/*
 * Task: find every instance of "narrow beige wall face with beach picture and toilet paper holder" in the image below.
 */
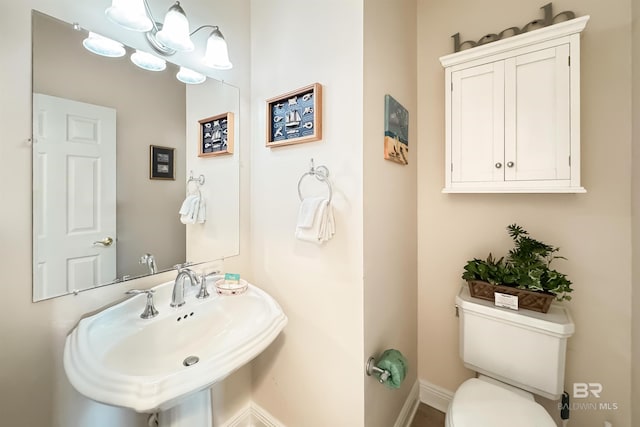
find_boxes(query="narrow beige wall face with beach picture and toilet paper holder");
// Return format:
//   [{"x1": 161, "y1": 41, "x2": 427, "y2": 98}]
[{"x1": 363, "y1": 0, "x2": 419, "y2": 427}]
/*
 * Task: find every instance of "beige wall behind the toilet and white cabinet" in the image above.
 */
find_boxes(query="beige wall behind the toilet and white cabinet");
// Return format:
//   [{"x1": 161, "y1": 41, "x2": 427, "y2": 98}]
[{"x1": 418, "y1": 0, "x2": 631, "y2": 426}]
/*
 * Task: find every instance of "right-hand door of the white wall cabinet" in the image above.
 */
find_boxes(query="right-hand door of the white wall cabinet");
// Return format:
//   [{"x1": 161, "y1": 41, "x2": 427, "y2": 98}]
[{"x1": 504, "y1": 44, "x2": 571, "y2": 181}]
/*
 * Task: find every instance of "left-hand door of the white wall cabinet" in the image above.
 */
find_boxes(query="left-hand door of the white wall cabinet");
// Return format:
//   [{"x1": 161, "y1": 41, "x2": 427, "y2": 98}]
[{"x1": 449, "y1": 61, "x2": 504, "y2": 182}]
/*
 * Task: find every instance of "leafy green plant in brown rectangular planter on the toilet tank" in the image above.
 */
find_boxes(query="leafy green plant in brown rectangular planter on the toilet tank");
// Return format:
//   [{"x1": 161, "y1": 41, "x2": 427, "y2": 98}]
[{"x1": 462, "y1": 224, "x2": 573, "y2": 313}]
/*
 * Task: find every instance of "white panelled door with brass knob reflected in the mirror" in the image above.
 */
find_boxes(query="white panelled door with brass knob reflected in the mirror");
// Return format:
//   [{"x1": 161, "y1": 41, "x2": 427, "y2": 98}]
[{"x1": 33, "y1": 94, "x2": 116, "y2": 299}]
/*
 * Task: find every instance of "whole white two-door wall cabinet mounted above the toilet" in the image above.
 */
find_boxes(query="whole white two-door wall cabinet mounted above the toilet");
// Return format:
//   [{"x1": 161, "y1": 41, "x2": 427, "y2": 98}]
[{"x1": 440, "y1": 16, "x2": 589, "y2": 193}]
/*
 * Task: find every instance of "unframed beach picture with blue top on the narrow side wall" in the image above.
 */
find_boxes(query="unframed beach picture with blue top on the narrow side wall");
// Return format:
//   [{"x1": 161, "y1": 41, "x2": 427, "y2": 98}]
[{"x1": 384, "y1": 95, "x2": 409, "y2": 165}]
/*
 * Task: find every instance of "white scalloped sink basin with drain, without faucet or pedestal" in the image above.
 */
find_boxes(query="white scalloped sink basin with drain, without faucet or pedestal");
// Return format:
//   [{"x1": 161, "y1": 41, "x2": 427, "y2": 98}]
[{"x1": 64, "y1": 281, "x2": 287, "y2": 412}]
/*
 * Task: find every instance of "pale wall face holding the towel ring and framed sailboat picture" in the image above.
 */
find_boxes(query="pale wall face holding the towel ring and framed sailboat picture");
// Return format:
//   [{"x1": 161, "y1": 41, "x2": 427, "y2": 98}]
[{"x1": 250, "y1": 0, "x2": 364, "y2": 427}]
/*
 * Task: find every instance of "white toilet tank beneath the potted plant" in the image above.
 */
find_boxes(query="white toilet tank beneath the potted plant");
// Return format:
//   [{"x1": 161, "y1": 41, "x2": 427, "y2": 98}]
[{"x1": 456, "y1": 284, "x2": 575, "y2": 400}]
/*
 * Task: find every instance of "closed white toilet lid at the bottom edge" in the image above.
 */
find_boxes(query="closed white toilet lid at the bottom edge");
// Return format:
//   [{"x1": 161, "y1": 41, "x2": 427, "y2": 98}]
[{"x1": 448, "y1": 378, "x2": 556, "y2": 427}]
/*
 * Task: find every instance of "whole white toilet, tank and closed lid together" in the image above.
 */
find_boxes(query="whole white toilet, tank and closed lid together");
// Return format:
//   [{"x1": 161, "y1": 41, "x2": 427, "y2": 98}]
[{"x1": 445, "y1": 285, "x2": 575, "y2": 427}]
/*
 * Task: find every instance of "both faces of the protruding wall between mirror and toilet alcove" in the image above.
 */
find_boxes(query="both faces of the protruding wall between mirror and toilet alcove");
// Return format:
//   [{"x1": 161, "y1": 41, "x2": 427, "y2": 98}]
[{"x1": 251, "y1": 0, "x2": 417, "y2": 426}]
